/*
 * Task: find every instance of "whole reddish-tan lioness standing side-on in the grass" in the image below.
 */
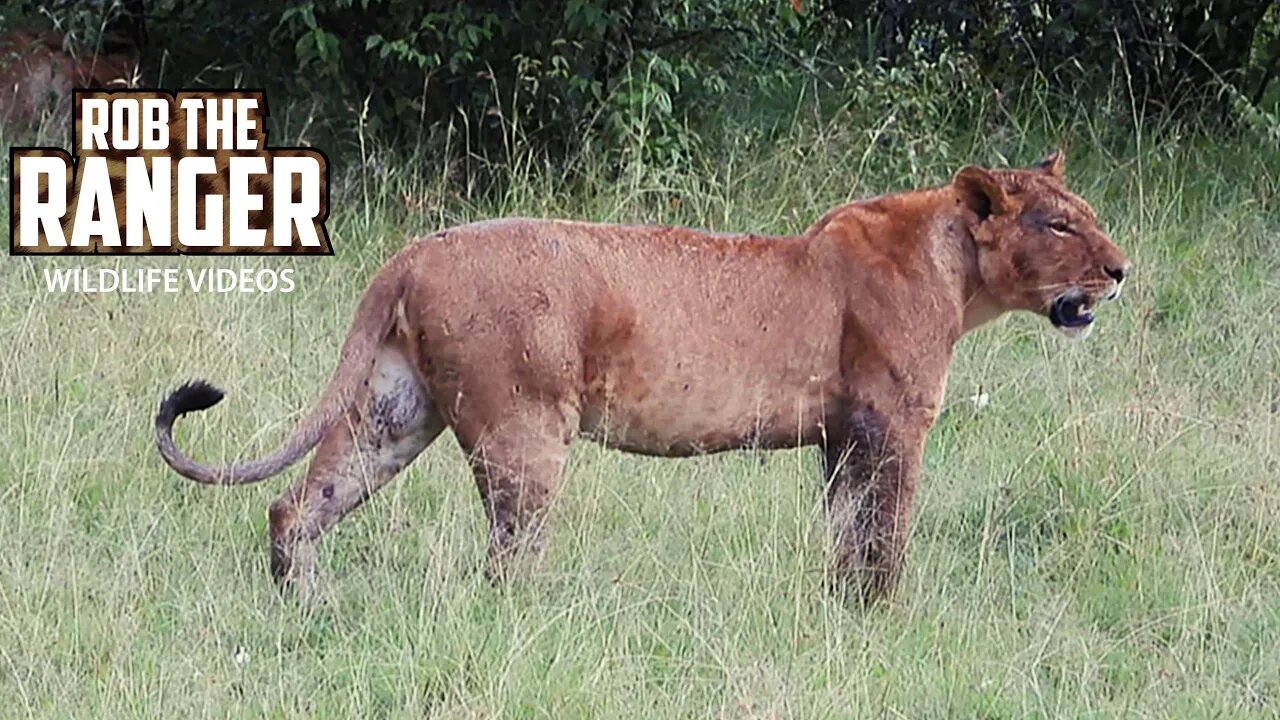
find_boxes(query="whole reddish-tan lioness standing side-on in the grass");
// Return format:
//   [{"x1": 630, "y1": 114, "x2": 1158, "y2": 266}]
[{"x1": 156, "y1": 152, "x2": 1129, "y2": 600}]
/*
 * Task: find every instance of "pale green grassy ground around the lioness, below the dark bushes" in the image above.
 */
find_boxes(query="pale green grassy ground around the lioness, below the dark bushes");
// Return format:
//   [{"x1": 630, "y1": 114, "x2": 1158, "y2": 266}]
[{"x1": 0, "y1": 90, "x2": 1280, "y2": 717}]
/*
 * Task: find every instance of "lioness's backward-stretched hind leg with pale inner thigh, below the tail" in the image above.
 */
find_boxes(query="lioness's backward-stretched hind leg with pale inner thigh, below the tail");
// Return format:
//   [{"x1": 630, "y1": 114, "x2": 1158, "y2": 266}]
[{"x1": 269, "y1": 346, "x2": 444, "y2": 585}]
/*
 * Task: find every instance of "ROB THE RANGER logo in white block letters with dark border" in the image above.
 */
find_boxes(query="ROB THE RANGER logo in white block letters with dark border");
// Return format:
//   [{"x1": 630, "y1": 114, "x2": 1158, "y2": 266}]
[{"x1": 9, "y1": 90, "x2": 333, "y2": 253}]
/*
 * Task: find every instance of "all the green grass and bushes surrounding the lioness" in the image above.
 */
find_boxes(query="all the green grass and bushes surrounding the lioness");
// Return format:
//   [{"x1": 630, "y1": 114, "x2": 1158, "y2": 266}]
[{"x1": 0, "y1": 1, "x2": 1280, "y2": 717}]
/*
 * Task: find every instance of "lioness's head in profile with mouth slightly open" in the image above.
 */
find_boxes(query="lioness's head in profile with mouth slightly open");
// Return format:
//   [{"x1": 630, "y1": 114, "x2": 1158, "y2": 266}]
[{"x1": 952, "y1": 152, "x2": 1130, "y2": 337}]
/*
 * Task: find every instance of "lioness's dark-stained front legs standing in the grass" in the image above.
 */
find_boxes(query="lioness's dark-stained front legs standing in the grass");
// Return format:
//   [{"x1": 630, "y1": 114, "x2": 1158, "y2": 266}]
[{"x1": 823, "y1": 410, "x2": 924, "y2": 602}]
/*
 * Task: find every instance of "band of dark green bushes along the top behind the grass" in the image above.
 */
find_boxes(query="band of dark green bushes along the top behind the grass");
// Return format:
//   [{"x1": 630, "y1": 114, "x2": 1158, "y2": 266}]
[{"x1": 14, "y1": 0, "x2": 1280, "y2": 168}]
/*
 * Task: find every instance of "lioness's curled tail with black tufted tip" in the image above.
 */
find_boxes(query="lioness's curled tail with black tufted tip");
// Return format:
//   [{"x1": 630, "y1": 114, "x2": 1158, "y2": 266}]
[{"x1": 156, "y1": 254, "x2": 404, "y2": 486}]
